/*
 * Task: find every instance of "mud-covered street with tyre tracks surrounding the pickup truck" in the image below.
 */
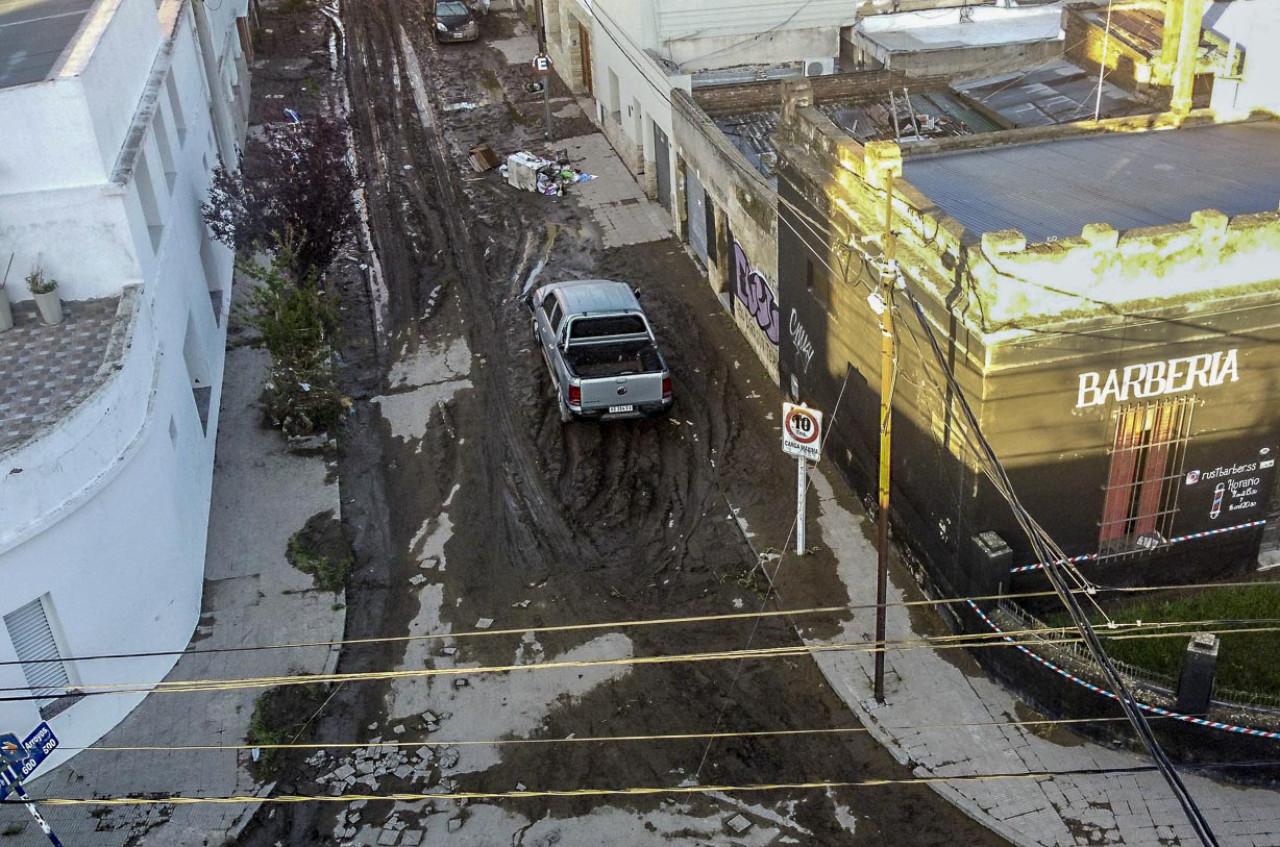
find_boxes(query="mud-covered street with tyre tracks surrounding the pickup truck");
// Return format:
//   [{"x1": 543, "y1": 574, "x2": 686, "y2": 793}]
[{"x1": 232, "y1": 0, "x2": 1002, "y2": 847}]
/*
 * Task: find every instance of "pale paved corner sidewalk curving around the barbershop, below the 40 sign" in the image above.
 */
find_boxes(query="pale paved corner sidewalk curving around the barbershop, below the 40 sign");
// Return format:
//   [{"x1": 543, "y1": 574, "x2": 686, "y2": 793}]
[{"x1": 809, "y1": 471, "x2": 1280, "y2": 847}]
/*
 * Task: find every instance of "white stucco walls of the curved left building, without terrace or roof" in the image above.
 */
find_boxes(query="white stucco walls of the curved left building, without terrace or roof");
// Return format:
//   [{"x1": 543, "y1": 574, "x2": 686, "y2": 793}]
[{"x1": 0, "y1": 0, "x2": 240, "y2": 772}]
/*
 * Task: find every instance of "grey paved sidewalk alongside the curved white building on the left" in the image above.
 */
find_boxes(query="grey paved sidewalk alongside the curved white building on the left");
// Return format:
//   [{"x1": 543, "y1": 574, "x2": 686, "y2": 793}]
[{"x1": 0, "y1": 289, "x2": 346, "y2": 847}]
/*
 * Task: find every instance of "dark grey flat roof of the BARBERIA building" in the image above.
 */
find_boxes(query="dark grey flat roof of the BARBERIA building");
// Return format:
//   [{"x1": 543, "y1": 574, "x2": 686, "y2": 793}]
[{"x1": 902, "y1": 123, "x2": 1280, "y2": 242}]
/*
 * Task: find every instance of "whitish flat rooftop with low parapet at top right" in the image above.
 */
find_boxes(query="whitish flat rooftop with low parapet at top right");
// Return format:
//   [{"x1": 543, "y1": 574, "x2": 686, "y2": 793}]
[{"x1": 854, "y1": 3, "x2": 1062, "y2": 52}]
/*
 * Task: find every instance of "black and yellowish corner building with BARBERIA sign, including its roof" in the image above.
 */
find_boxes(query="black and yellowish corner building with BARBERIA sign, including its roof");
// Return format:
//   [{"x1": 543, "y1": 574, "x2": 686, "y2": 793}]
[{"x1": 777, "y1": 91, "x2": 1280, "y2": 596}]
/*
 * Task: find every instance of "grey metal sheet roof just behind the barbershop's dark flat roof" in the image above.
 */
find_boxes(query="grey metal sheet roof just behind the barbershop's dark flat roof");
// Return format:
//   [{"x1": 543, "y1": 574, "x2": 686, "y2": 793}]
[{"x1": 955, "y1": 59, "x2": 1151, "y2": 127}]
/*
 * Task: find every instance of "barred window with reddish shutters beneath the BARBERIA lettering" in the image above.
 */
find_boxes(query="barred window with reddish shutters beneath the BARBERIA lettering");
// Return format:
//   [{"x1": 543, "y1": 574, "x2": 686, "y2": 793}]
[{"x1": 1098, "y1": 397, "x2": 1196, "y2": 554}]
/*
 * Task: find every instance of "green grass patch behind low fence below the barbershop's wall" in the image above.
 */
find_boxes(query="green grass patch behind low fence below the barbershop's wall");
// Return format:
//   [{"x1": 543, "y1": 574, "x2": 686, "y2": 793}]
[{"x1": 1050, "y1": 581, "x2": 1280, "y2": 695}]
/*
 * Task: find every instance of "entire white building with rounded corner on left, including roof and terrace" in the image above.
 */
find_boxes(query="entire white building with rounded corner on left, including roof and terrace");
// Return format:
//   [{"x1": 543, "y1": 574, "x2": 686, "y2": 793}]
[{"x1": 0, "y1": 0, "x2": 250, "y2": 769}]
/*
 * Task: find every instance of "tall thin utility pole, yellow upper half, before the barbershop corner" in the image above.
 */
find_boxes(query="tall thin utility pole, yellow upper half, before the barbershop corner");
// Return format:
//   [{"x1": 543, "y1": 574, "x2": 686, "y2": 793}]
[{"x1": 874, "y1": 169, "x2": 897, "y2": 702}]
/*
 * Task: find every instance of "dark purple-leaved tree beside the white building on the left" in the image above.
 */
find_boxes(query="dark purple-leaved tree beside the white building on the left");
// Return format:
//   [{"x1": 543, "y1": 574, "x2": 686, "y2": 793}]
[{"x1": 201, "y1": 116, "x2": 356, "y2": 280}]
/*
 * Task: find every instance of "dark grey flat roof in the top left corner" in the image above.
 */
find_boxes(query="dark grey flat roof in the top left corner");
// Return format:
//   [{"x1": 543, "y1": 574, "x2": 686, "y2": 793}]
[{"x1": 0, "y1": 0, "x2": 96, "y2": 88}]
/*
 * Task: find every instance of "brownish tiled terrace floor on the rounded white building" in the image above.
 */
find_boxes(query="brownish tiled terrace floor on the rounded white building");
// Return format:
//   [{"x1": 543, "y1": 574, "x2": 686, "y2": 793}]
[{"x1": 0, "y1": 298, "x2": 120, "y2": 453}]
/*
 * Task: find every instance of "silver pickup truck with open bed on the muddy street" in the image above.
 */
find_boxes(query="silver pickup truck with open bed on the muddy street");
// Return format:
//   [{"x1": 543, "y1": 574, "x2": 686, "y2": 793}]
[{"x1": 530, "y1": 279, "x2": 672, "y2": 421}]
